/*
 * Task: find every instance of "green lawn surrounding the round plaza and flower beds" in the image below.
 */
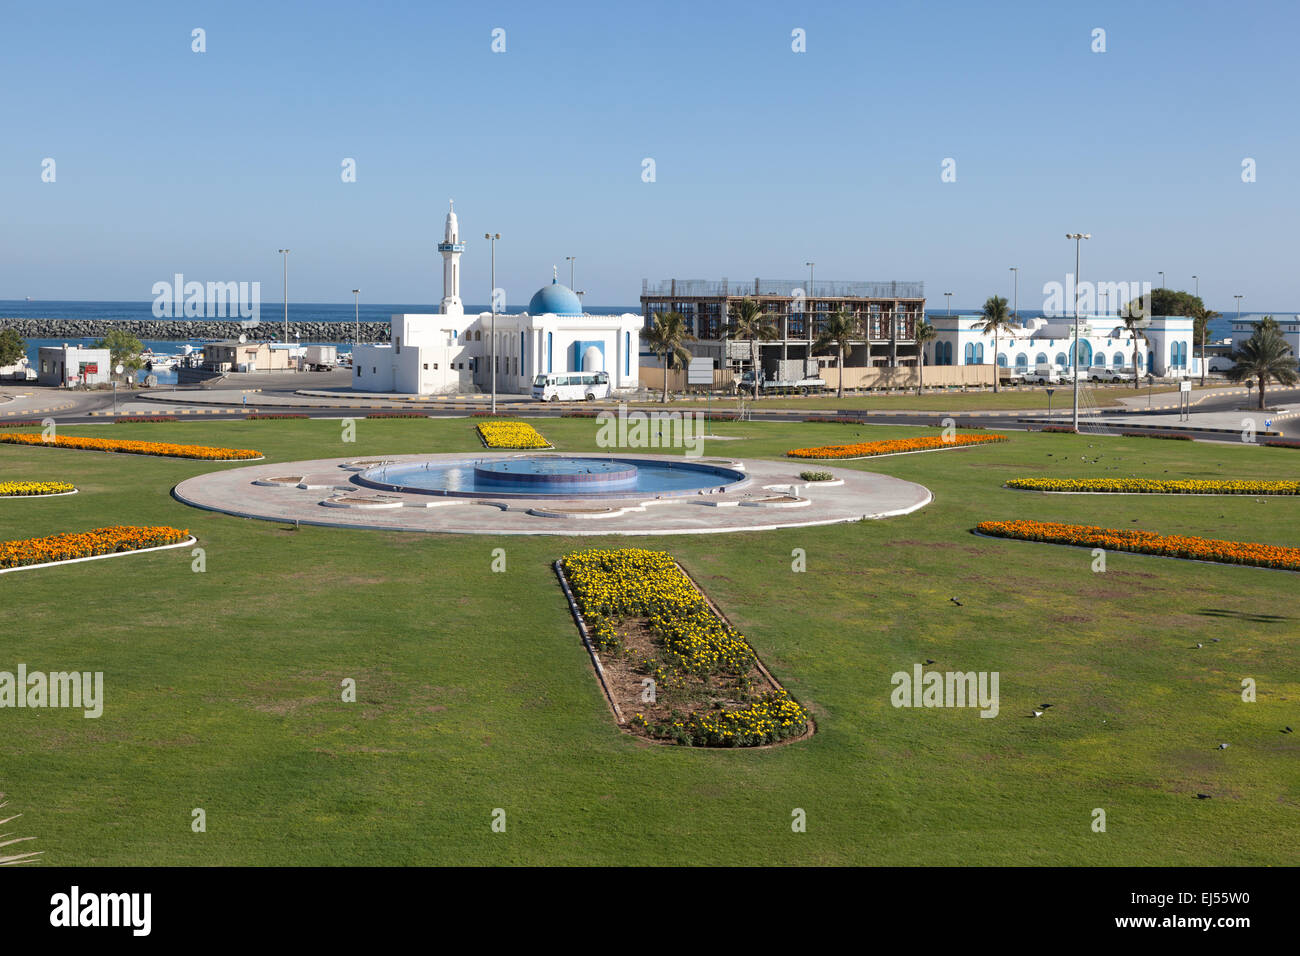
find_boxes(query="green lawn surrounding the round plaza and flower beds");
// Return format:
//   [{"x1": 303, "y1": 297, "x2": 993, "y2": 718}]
[{"x1": 0, "y1": 419, "x2": 1300, "y2": 865}]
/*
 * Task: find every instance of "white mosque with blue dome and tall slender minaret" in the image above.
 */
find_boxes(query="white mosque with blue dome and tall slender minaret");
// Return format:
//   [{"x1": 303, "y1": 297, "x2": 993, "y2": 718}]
[{"x1": 352, "y1": 204, "x2": 644, "y2": 395}]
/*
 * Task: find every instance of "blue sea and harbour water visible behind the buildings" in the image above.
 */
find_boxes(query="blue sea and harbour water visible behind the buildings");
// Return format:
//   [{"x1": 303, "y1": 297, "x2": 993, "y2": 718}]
[{"x1": 0, "y1": 299, "x2": 1268, "y2": 385}]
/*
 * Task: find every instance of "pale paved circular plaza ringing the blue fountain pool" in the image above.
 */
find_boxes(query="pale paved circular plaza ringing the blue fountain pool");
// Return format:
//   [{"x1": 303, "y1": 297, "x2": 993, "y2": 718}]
[{"x1": 174, "y1": 451, "x2": 931, "y2": 535}]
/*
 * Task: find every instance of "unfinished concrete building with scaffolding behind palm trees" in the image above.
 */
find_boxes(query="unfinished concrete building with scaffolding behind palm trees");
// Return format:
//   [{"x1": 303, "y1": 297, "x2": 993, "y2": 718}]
[{"x1": 641, "y1": 278, "x2": 926, "y2": 377}]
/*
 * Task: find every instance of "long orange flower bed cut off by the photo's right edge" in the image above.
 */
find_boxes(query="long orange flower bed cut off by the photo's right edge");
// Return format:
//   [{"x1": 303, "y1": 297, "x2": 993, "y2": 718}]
[{"x1": 975, "y1": 520, "x2": 1300, "y2": 571}]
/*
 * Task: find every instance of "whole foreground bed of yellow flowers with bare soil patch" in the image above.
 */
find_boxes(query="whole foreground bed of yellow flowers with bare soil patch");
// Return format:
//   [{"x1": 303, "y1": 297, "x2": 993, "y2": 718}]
[{"x1": 560, "y1": 548, "x2": 809, "y2": 747}]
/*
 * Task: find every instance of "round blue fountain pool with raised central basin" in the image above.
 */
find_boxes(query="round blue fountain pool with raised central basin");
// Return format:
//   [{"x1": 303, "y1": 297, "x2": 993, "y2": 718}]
[{"x1": 355, "y1": 455, "x2": 746, "y2": 498}]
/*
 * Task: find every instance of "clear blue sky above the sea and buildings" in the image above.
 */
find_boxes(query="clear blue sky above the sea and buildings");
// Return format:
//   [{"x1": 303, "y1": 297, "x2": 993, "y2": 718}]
[{"x1": 0, "y1": 0, "x2": 1300, "y2": 311}]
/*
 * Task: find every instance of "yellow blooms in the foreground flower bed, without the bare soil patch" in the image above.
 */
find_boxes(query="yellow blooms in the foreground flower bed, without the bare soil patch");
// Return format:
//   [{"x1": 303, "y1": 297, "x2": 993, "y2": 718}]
[{"x1": 562, "y1": 548, "x2": 809, "y2": 747}]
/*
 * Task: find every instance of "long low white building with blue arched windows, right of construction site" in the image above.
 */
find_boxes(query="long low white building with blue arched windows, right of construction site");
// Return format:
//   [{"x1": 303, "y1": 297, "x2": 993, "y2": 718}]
[{"x1": 926, "y1": 315, "x2": 1200, "y2": 377}]
